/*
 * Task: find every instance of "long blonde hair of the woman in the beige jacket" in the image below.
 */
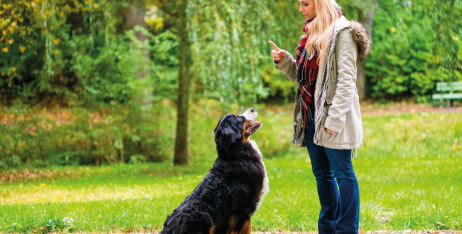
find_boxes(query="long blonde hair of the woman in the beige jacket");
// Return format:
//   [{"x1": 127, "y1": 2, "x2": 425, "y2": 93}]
[{"x1": 306, "y1": 0, "x2": 339, "y2": 64}]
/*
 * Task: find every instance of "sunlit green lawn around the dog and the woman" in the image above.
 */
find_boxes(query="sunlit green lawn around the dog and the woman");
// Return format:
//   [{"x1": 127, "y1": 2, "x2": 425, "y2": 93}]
[{"x1": 0, "y1": 108, "x2": 462, "y2": 232}]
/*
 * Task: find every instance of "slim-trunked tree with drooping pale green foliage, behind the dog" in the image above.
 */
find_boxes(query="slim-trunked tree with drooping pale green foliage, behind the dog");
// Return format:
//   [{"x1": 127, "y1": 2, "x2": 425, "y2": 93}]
[{"x1": 154, "y1": 0, "x2": 275, "y2": 165}]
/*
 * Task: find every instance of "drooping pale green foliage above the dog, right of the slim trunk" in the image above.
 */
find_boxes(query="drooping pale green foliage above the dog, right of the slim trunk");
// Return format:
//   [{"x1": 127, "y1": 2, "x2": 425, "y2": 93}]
[{"x1": 188, "y1": 0, "x2": 275, "y2": 106}]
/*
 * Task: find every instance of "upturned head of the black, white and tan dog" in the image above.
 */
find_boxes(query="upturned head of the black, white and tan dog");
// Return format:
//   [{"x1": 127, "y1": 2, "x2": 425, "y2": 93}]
[{"x1": 215, "y1": 108, "x2": 261, "y2": 149}]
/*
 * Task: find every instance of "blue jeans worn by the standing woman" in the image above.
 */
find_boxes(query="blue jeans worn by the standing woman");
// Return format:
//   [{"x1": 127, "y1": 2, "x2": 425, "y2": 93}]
[{"x1": 305, "y1": 114, "x2": 359, "y2": 234}]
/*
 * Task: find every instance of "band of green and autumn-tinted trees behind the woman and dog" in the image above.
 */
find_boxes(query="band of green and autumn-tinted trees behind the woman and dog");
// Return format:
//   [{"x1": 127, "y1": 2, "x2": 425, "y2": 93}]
[{"x1": 0, "y1": 0, "x2": 462, "y2": 168}]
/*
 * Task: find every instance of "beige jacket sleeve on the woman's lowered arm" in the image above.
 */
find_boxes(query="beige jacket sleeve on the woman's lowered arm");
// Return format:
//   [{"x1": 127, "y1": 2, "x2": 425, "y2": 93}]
[{"x1": 324, "y1": 29, "x2": 358, "y2": 132}]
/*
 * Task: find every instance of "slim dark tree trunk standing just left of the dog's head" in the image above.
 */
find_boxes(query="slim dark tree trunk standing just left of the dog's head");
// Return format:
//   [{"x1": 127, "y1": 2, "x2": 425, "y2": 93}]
[{"x1": 173, "y1": 0, "x2": 191, "y2": 165}]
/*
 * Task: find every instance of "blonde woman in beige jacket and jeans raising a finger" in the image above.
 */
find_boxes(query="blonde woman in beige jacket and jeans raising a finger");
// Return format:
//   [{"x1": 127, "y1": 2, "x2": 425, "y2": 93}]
[{"x1": 270, "y1": 0, "x2": 370, "y2": 234}]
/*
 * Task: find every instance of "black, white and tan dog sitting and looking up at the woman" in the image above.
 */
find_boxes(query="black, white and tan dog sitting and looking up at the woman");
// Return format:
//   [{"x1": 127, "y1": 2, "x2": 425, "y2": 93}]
[{"x1": 161, "y1": 108, "x2": 269, "y2": 234}]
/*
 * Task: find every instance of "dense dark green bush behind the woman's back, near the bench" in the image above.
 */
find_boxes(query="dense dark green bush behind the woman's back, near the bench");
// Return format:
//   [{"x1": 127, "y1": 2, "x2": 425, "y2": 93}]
[{"x1": 365, "y1": 1, "x2": 462, "y2": 102}]
